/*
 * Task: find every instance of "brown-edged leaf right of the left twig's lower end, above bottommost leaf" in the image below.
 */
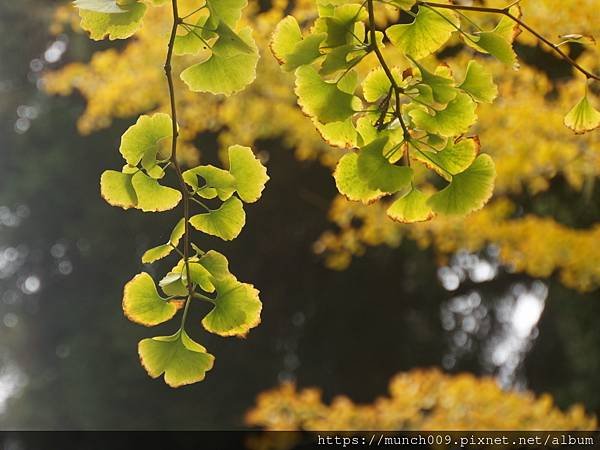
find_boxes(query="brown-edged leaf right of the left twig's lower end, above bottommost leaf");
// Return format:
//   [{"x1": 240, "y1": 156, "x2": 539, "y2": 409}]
[{"x1": 202, "y1": 277, "x2": 262, "y2": 336}]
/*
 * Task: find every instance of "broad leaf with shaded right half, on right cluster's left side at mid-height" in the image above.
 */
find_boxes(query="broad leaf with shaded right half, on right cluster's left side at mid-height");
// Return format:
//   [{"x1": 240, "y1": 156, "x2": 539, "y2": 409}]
[{"x1": 296, "y1": 66, "x2": 362, "y2": 123}]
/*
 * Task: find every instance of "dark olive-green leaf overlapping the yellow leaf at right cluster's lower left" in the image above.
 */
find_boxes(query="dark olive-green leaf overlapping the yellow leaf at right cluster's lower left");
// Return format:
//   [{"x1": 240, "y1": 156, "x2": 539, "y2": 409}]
[{"x1": 357, "y1": 137, "x2": 413, "y2": 194}]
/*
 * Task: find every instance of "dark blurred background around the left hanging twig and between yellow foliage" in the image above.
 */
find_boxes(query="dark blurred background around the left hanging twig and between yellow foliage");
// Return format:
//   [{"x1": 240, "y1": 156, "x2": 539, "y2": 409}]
[{"x1": 0, "y1": 0, "x2": 600, "y2": 429}]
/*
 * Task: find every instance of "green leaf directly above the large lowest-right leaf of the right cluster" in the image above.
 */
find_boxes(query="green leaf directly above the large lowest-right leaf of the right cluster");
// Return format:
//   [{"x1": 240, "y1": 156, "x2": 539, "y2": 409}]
[{"x1": 412, "y1": 137, "x2": 480, "y2": 181}]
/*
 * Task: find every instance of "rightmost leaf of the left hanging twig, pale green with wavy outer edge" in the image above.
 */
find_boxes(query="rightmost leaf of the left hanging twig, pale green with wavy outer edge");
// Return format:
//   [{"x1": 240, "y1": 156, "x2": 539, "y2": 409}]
[{"x1": 229, "y1": 145, "x2": 269, "y2": 203}]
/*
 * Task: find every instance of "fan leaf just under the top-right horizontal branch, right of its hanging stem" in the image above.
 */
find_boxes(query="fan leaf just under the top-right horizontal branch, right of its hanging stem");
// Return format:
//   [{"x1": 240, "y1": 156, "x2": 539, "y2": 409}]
[{"x1": 386, "y1": 6, "x2": 460, "y2": 59}]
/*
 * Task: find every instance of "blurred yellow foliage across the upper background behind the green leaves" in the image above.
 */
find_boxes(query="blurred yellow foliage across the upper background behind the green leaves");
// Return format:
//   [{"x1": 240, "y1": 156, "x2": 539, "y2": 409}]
[{"x1": 45, "y1": 0, "x2": 600, "y2": 291}]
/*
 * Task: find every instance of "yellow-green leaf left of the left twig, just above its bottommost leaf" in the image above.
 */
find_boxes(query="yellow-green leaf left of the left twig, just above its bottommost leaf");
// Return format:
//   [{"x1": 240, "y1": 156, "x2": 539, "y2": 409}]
[{"x1": 123, "y1": 272, "x2": 177, "y2": 326}]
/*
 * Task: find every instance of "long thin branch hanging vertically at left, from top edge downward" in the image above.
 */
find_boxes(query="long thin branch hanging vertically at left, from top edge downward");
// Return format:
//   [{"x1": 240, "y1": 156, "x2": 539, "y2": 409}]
[{"x1": 165, "y1": 0, "x2": 194, "y2": 329}]
